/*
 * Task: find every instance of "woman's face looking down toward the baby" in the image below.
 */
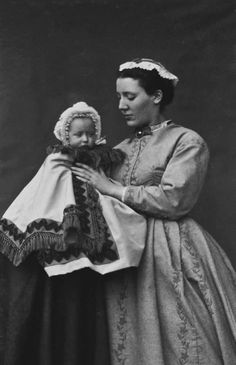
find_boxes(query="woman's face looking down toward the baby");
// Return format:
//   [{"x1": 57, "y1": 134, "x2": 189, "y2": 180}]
[{"x1": 116, "y1": 77, "x2": 159, "y2": 127}]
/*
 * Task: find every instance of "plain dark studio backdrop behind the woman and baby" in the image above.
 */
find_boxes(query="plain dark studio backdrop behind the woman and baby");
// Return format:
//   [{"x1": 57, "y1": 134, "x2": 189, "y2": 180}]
[{"x1": 0, "y1": 0, "x2": 236, "y2": 267}]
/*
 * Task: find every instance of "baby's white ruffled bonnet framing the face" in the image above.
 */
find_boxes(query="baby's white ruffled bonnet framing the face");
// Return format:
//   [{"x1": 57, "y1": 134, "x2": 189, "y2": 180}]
[{"x1": 54, "y1": 101, "x2": 101, "y2": 146}]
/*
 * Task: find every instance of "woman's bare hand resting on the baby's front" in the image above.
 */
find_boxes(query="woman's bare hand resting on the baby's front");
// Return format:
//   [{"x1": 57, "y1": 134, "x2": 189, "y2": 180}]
[{"x1": 71, "y1": 163, "x2": 114, "y2": 195}]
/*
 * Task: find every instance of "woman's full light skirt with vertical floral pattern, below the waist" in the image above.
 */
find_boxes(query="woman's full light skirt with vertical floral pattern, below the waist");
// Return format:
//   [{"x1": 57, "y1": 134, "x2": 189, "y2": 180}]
[{"x1": 105, "y1": 218, "x2": 236, "y2": 365}]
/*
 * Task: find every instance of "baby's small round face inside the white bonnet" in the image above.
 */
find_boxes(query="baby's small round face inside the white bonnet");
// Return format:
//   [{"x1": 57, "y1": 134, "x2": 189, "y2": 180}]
[{"x1": 69, "y1": 118, "x2": 96, "y2": 148}]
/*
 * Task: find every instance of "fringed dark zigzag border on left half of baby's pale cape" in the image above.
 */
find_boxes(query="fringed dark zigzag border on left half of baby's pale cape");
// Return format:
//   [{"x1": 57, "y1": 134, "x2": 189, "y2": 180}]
[{"x1": 0, "y1": 206, "x2": 84, "y2": 266}]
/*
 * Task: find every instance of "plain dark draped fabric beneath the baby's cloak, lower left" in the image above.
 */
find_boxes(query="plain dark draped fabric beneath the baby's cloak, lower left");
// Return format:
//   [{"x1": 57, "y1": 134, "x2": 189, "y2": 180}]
[{"x1": 0, "y1": 255, "x2": 110, "y2": 365}]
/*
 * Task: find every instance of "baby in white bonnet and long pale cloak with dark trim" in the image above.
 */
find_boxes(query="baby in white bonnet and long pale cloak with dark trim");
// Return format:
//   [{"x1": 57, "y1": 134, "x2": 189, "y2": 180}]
[{"x1": 0, "y1": 102, "x2": 146, "y2": 276}]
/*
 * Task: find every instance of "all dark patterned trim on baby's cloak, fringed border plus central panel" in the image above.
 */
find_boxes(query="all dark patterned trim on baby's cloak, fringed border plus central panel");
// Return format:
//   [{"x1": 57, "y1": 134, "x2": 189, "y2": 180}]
[{"x1": 0, "y1": 186, "x2": 118, "y2": 266}]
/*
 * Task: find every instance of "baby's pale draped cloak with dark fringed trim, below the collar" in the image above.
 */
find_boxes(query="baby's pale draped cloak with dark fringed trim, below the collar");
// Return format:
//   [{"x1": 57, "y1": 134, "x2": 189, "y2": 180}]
[{"x1": 0, "y1": 152, "x2": 146, "y2": 275}]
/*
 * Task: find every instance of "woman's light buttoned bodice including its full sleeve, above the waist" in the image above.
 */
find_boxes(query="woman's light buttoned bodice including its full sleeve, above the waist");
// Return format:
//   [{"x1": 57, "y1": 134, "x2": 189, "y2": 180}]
[{"x1": 112, "y1": 123, "x2": 208, "y2": 219}]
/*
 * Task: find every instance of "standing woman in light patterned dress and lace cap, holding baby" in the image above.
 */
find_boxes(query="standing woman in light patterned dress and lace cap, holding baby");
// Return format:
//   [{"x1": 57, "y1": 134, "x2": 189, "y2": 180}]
[{"x1": 74, "y1": 59, "x2": 236, "y2": 365}]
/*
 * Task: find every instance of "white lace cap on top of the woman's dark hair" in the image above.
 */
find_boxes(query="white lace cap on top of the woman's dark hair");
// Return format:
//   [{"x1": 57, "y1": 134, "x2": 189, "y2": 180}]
[{"x1": 119, "y1": 59, "x2": 179, "y2": 86}]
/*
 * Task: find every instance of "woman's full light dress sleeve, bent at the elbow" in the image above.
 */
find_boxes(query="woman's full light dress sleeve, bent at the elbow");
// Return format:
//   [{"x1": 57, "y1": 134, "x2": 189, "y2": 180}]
[{"x1": 123, "y1": 135, "x2": 209, "y2": 219}]
